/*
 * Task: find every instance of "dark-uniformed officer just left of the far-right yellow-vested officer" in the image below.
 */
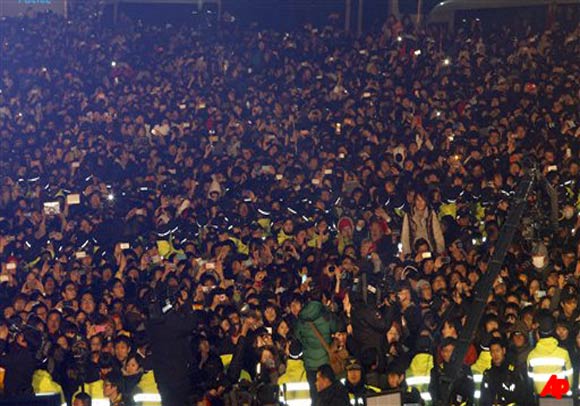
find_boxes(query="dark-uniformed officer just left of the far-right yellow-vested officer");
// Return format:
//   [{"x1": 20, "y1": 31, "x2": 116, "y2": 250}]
[{"x1": 479, "y1": 338, "x2": 534, "y2": 406}]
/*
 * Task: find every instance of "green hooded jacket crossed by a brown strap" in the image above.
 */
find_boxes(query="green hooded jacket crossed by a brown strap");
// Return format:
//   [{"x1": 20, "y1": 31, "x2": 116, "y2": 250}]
[{"x1": 296, "y1": 301, "x2": 337, "y2": 371}]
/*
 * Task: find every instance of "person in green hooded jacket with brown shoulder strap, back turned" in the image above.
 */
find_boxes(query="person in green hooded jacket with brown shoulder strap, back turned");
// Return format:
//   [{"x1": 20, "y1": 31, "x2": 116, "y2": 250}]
[{"x1": 296, "y1": 289, "x2": 337, "y2": 404}]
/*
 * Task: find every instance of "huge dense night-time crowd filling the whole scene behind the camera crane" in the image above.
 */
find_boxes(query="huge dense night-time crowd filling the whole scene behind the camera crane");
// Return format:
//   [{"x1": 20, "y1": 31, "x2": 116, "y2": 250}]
[{"x1": 0, "y1": 1, "x2": 580, "y2": 406}]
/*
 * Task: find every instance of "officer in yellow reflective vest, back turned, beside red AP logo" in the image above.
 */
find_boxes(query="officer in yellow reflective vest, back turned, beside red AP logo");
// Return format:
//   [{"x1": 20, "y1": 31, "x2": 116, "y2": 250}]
[{"x1": 528, "y1": 312, "x2": 573, "y2": 394}]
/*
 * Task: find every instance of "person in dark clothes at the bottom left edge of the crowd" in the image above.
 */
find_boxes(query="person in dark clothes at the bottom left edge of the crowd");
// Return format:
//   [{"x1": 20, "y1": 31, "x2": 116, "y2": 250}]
[{"x1": 0, "y1": 324, "x2": 42, "y2": 397}]
